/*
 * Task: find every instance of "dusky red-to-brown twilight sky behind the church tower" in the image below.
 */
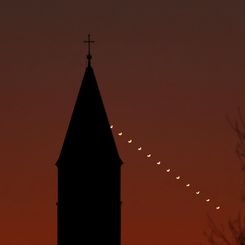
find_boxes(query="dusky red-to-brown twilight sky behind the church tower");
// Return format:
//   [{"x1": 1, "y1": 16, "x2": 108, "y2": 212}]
[{"x1": 0, "y1": 0, "x2": 245, "y2": 245}]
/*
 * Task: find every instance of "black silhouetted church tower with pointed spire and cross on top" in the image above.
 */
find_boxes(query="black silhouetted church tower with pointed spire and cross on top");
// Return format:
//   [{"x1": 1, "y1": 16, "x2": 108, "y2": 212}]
[{"x1": 56, "y1": 36, "x2": 122, "y2": 245}]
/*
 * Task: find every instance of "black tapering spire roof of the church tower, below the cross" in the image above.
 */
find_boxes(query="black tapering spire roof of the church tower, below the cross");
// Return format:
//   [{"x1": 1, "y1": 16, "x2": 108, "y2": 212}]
[{"x1": 57, "y1": 57, "x2": 121, "y2": 165}]
